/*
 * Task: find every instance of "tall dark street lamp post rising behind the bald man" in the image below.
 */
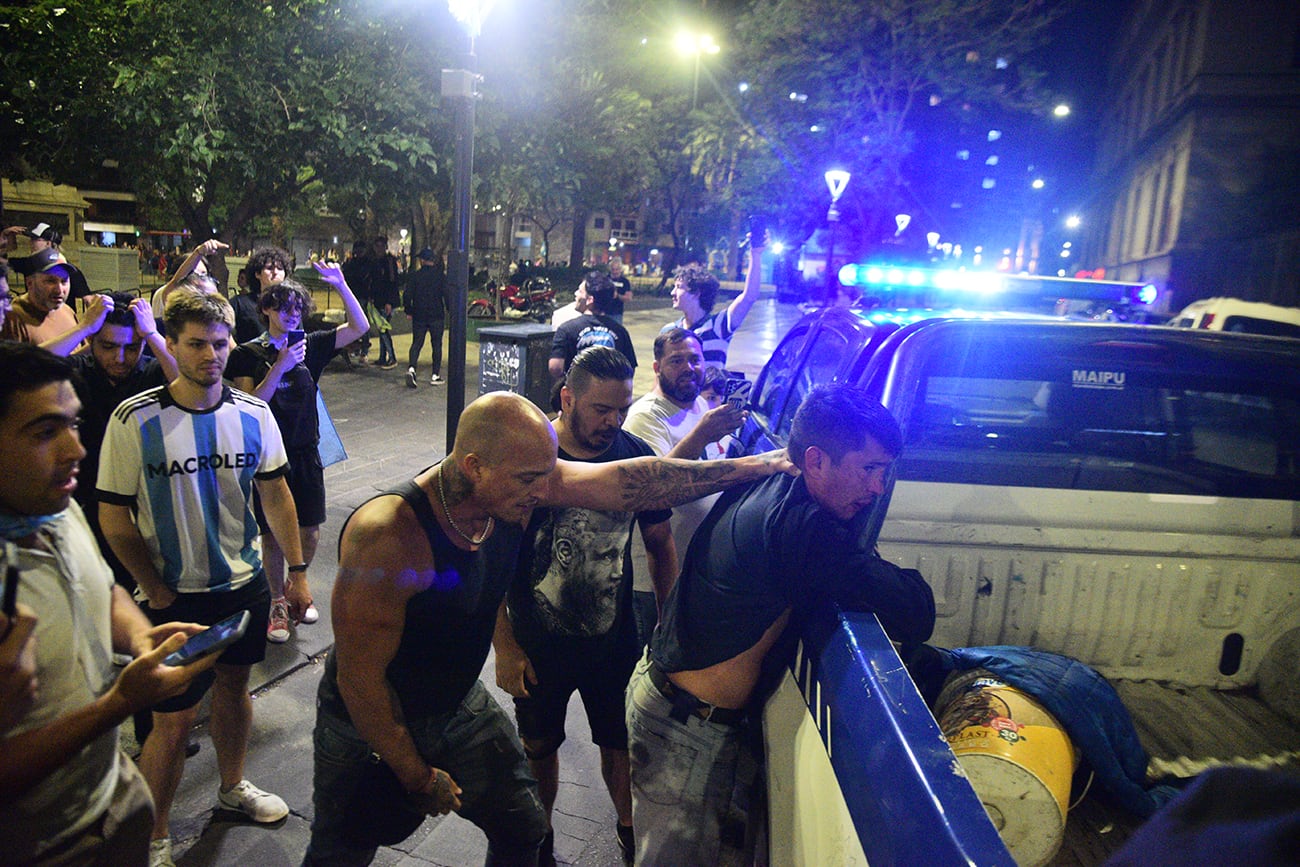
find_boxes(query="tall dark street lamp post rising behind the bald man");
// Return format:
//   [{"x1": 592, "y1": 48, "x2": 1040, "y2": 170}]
[{"x1": 442, "y1": 0, "x2": 493, "y2": 452}]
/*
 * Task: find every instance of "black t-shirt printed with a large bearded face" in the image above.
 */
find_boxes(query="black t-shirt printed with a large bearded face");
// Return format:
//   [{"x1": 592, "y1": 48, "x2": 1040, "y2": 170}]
[{"x1": 506, "y1": 430, "x2": 672, "y2": 653}]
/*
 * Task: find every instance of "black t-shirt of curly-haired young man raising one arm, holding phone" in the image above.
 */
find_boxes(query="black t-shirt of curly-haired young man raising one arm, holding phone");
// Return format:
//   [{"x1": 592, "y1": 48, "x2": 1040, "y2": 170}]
[{"x1": 226, "y1": 328, "x2": 338, "y2": 450}]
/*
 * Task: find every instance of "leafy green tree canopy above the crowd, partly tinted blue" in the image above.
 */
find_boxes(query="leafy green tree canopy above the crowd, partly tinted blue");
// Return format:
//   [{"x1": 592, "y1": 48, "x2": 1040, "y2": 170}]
[{"x1": 0, "y1": 0, "x2": 1058, "y2": 267}]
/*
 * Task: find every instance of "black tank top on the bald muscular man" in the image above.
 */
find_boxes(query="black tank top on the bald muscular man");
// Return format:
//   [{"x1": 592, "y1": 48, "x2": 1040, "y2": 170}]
[{"x1": 320, "y1": 481, "x2": 521, "y2": 720}]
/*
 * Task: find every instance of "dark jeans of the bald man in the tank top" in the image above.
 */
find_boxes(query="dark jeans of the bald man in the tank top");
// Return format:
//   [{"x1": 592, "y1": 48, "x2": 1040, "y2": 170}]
[{"x1": 303, "y1": 681, "x2": 547, "y2": 867}]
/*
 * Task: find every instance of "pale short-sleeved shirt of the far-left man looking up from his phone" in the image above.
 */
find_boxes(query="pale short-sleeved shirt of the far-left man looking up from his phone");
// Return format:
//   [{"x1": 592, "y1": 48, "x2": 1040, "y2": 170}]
[{"x1": 0, "y1": 500, "x2": 117, "y2": 863}]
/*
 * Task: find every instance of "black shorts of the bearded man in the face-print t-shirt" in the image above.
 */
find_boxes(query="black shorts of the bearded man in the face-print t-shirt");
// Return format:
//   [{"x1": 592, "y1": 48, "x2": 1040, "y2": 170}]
[{"x1": 515, "y1": 636, "x2": 640, "y2": 759}]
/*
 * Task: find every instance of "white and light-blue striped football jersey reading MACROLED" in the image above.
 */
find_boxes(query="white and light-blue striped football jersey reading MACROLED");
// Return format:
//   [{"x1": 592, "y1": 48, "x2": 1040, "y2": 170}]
[{"x1": 96, "y1": 386, "x2": 289, "y2": 593}]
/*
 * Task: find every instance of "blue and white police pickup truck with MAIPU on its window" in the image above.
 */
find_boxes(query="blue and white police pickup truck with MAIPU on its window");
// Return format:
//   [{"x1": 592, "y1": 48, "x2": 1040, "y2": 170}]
[{"x1": 740, "y1": 311, "x2": 1300, "y2": 864}]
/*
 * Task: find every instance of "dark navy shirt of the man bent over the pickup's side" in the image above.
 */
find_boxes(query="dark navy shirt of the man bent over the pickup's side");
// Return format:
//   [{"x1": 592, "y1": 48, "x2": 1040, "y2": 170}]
[{"x1": 650, "y1": 474, "x2": 935, "y2": 686}]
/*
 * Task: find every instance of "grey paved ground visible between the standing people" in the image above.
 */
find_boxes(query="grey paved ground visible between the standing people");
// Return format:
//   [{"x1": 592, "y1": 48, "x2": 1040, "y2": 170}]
[{"x1": 149, "y1": 295, "x2": 800, "y2": 867}]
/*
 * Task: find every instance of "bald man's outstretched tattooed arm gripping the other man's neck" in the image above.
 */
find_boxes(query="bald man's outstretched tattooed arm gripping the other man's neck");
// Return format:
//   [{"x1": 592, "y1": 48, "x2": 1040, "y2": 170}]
[{"x1": 541, "y1": 448, "x2": 798, "y2": 512}]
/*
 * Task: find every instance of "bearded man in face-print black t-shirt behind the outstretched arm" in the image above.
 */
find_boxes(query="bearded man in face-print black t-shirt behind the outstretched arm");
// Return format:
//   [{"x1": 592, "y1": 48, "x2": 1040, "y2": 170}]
[{"x1": 493, "y1": 346, "x2": 677, "y2": 864}]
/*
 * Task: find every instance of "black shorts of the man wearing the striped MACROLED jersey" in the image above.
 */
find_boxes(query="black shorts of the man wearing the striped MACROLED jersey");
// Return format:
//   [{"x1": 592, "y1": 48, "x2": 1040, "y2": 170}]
[{"x1": 140, "y1": 572, "x2": 270, "y2": 714}]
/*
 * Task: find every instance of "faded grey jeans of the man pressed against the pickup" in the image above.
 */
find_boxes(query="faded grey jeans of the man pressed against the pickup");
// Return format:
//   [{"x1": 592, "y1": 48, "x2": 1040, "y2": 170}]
[{"x1": 628, "y1": 656, "x2": 744, "y2": 866}]
